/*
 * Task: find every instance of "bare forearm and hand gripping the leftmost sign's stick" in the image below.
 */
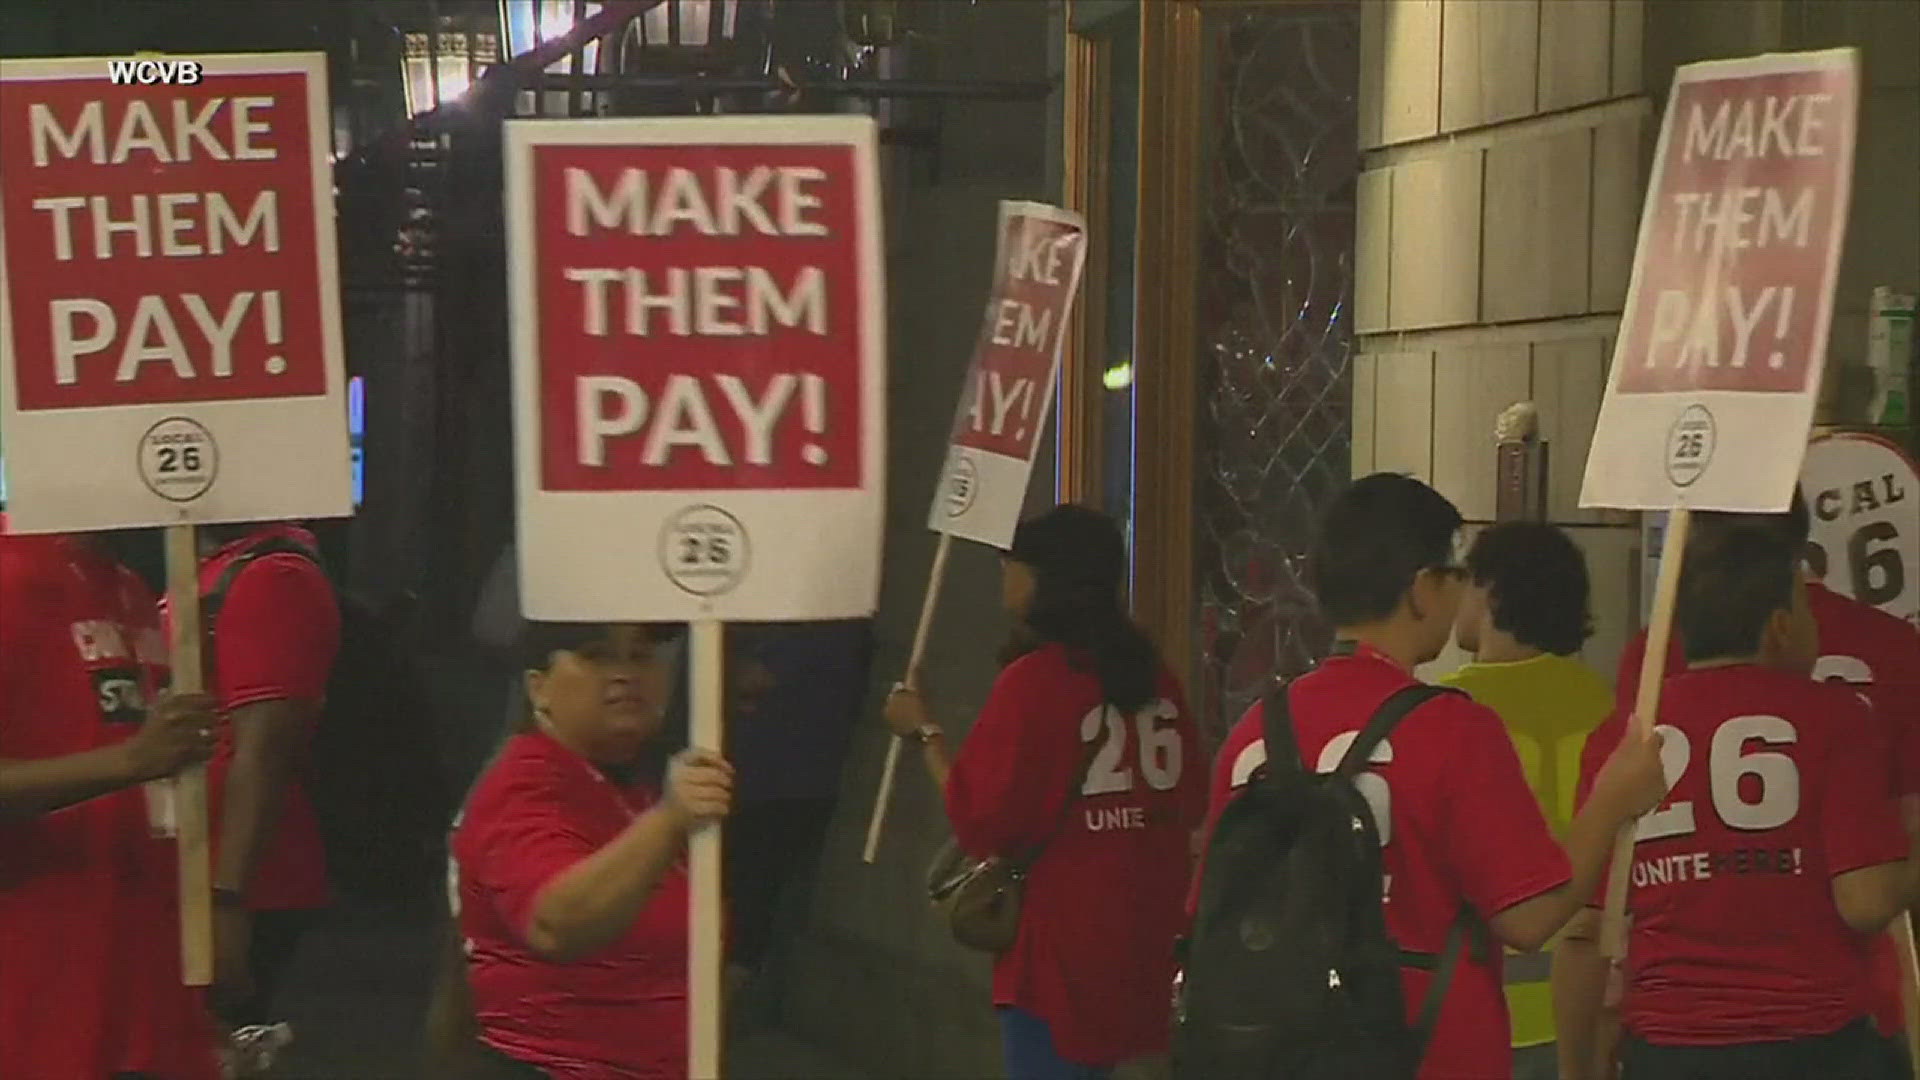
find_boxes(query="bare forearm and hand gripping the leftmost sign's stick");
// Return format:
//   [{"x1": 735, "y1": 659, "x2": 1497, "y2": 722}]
[{"x1": 0, "y1": 696, "x2": 213, "y2": 819}]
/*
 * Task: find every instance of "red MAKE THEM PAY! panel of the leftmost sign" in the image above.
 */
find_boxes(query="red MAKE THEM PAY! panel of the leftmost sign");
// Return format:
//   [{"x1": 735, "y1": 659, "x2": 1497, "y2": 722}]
[{"x1": 0, "y1": 69, "x2": 330, "y2": 411}]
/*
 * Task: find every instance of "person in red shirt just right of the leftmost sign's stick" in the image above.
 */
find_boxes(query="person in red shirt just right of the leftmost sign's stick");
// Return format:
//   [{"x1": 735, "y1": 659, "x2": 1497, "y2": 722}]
[{"x1": 183, "y1": 525, "x2": 340, "y2": 1026}]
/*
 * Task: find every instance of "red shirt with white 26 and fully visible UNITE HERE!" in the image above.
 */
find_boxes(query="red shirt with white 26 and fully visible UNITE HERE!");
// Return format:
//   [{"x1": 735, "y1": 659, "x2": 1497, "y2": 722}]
[{"x1": 1580, "y1": 665, "x2": 1907, "y2": 1045}]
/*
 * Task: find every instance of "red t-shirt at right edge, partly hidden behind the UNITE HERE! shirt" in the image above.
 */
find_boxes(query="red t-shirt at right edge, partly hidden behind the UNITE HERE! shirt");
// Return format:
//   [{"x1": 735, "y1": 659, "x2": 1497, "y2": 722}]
[{"x1": 1617, "y1": 584, "x2": 1920, "y2": 1036}]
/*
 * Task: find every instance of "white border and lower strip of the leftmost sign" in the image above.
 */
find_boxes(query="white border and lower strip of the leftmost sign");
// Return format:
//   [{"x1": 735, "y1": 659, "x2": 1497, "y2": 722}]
[{"x1": 0, "y1": 52, "x2": 353, "y2": 534}]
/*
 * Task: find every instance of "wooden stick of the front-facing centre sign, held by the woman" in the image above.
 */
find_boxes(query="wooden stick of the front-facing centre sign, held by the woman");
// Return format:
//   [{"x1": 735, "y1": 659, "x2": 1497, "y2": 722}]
[{"x1": 687, "y1": 619, "x2": 726, "y2": 1080}]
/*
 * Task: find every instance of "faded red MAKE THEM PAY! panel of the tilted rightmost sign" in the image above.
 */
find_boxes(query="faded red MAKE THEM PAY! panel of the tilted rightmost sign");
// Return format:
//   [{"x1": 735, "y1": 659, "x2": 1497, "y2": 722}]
[{"x1": 1617, "y1": 67, "x2": 1855, "y2": 394}]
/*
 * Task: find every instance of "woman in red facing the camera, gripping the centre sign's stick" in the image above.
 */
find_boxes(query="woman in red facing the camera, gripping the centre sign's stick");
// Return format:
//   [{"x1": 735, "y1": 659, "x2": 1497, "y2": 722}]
[{"x1": 441, "y1": 625, "x2": 733, "y2": 1080}]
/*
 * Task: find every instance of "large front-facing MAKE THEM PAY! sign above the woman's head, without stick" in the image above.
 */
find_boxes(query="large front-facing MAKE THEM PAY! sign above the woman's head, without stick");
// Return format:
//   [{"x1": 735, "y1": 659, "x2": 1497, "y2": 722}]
[{"x1": 507, "y1": 117, "x2": 885, "y2": 621}]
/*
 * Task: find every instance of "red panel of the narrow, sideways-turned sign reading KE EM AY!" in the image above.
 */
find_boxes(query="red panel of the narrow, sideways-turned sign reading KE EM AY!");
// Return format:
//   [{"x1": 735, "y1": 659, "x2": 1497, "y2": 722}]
[{"x1": 952, "y1": 211, "x2": 1087, "y2": 461}]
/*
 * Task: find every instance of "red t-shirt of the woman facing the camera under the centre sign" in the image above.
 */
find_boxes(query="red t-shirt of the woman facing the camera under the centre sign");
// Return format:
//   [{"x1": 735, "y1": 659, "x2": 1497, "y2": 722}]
[{"x1": 453, "y1": 732, "x2": 687, "y2": 1080}]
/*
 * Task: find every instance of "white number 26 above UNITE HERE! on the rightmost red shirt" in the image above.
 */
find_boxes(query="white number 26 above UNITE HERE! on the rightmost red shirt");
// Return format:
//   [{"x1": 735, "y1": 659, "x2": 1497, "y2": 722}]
[{"x1": 1634, "y1": 717, "x2": 1799, "y2": 842}]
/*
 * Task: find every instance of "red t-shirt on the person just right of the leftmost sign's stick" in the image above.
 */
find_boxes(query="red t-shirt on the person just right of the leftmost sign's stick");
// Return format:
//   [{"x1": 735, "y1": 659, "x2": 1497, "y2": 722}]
[{"x1": 167, "y1": 525, "x2": 340, "y2": 911}]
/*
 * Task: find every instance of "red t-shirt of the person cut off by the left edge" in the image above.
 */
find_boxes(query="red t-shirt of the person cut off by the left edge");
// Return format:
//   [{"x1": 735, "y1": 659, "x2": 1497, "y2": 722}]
[{"x1": 0, "y1": 536, "x2": 219, "y2": 1080}]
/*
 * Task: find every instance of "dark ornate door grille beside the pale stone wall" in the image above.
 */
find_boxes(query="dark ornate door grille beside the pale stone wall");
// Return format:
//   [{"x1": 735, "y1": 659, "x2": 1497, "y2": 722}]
[{"x1": 1196, "y1": 0, "x2": 1359, "y2": 740}]
